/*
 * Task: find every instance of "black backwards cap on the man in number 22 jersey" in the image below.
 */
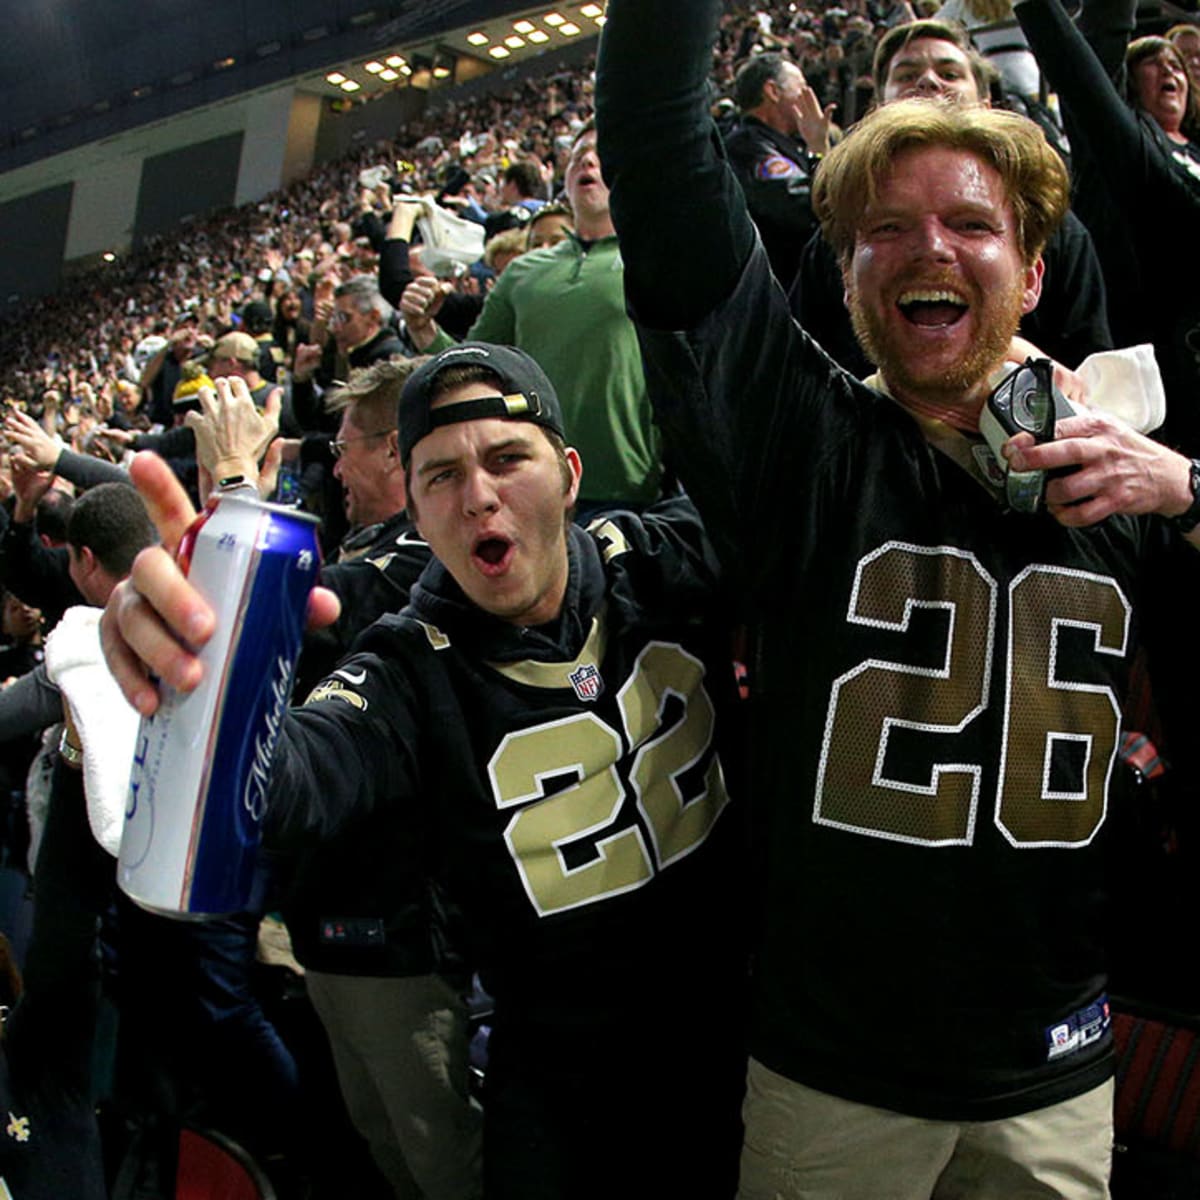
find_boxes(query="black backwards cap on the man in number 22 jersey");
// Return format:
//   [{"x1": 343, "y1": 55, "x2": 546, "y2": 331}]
[{"x1": 397, "y1": 342, "x2": 564, "y2": 467}]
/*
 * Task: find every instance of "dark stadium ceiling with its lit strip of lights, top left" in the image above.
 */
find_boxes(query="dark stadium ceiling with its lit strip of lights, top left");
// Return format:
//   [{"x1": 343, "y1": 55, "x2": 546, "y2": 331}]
[{"x1": 0, "y1": 0, "x2": 602, "y2": 174}]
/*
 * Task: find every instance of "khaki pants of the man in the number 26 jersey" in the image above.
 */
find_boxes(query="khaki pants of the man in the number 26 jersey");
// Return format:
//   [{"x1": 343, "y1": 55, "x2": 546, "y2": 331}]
[{"x1": 738, "y1": 1060, "x2": 1112, "y2": 1200}]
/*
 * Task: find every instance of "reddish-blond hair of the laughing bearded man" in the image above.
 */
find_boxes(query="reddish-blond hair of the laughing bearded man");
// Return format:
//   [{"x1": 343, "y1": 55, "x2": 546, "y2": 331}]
[{"x1": 812, "y1": 100, "x2": 1070, "y2": 265}]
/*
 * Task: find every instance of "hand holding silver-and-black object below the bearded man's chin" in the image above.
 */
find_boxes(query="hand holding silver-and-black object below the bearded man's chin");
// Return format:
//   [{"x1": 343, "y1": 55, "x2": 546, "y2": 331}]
[{"x1": 1004, "y1": 408, "x2": 1200, "y2": 530}]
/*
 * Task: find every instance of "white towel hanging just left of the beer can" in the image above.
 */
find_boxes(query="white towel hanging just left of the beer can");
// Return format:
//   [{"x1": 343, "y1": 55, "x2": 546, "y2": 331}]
[{"x1": 46, "y1": 605, "x2": 139, "y2": 856}]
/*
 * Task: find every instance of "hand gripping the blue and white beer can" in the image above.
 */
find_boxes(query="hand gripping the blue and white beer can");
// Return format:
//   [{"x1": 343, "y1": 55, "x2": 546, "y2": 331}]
[{"x1": 100, "y1": 452, "x2": 340, "y2": 715}]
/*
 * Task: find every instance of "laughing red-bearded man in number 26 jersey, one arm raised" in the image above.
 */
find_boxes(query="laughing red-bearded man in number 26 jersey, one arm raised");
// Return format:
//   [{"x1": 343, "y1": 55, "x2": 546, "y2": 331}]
[{"x1": 596, "y1": 0, "x2": 1200, "y2": 1200}]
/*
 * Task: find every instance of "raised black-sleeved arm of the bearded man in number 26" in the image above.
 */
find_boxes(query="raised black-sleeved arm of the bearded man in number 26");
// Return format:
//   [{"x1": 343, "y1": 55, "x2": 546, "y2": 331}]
[{"x1": 596, "y1": 0, "x2": 756, "y2": 329}]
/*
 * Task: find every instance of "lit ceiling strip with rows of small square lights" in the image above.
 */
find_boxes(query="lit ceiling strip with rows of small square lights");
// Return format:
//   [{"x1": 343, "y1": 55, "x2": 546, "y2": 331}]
[{"x1": 298, "y1": 2, "x2": 605, "y2": 101}]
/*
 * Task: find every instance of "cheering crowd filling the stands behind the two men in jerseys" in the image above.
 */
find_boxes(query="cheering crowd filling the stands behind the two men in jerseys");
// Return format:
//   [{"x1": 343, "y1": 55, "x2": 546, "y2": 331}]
[{"x1": 0, "y1": 0, "x2": 1200, "y2": 1195}]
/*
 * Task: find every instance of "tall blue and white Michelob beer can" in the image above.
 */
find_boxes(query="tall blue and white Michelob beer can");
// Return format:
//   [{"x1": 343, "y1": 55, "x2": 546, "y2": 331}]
[{"x1": 116, "y1": 490, "x2": 320, "y2": 918}]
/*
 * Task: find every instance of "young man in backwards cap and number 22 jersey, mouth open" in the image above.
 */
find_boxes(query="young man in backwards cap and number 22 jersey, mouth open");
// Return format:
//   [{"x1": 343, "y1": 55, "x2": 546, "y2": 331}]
[{"x1": 271, "y1": 343, "x2": 744, "y2": 1200}]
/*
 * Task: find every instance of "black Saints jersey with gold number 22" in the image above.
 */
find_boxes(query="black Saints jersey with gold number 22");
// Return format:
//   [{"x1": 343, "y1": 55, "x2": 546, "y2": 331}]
[{"x1": 272, "y1": 504, "x2": 739, "y2": 1028}]
